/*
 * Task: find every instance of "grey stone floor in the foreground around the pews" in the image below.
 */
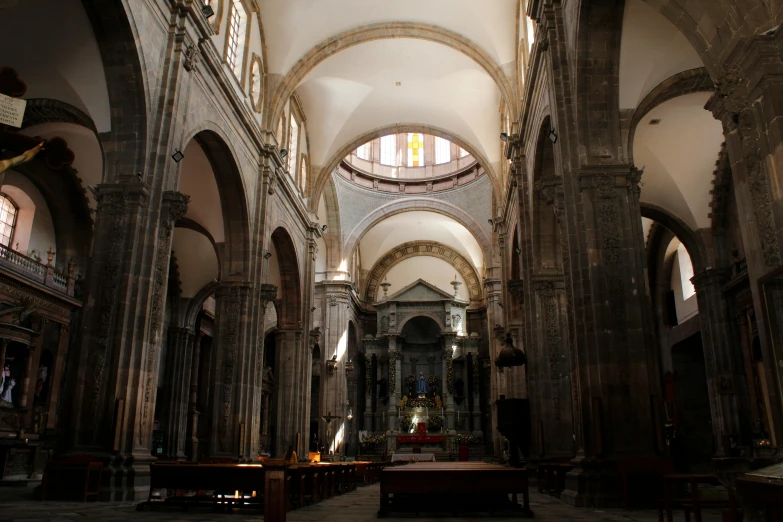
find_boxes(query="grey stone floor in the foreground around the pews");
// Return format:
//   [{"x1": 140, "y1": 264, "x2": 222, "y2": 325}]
[{"x1": 0, "y1": 484, "x2": 721, "y2": 522}]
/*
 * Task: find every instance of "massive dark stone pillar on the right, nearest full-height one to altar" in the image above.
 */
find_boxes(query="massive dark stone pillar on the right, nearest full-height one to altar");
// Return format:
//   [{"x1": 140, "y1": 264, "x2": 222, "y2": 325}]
[{"x1": 563, "y1": 165, "x2": 660, "y2": 506}]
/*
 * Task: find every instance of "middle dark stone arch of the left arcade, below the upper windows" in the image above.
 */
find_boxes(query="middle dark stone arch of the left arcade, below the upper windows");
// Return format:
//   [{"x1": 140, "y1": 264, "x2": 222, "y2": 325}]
[{"x1": 180, "y1": 129, "x2": 250, "y2": 280}]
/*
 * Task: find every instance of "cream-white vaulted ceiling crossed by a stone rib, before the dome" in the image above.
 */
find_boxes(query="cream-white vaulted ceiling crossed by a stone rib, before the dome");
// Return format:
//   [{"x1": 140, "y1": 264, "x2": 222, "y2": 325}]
[{"x1": 259, "y1": 0, "x2": 519, "y2": 189}]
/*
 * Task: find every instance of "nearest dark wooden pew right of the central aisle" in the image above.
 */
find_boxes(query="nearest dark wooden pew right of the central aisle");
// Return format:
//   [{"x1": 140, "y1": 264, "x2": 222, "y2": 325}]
[{"x1": 378, "y1": 462, "x2": 533, "y2": 517}]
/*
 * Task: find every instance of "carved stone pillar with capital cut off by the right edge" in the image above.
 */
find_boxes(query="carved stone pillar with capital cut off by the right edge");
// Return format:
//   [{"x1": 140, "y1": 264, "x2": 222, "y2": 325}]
[{"x1": 699, "y1": 49, "x2": 783, "y2": 438}]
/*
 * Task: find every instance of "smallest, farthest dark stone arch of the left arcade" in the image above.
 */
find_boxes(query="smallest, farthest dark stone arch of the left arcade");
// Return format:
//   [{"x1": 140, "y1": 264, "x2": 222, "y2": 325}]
[{"x1": 272, "y1": 227, "x2": 302, "y2": 328}]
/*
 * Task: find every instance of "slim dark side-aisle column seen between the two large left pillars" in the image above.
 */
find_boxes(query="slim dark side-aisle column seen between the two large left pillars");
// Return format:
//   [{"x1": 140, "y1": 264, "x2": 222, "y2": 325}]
[{"x1": 161, "y1": 327, "x2": 198, "y2": 460}]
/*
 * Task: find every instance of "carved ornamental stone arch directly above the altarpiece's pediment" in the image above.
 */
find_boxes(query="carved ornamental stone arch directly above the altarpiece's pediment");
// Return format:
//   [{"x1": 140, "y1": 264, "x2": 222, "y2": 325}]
[{"x1": 363, "y1": 241, "x2": 482, "y2": 303}]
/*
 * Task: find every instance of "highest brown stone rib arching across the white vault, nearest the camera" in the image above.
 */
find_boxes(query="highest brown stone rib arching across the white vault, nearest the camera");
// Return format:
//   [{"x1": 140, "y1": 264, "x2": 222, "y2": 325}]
[{"x1": 264, "y1": 22, "x2": 517, "y2": 134}]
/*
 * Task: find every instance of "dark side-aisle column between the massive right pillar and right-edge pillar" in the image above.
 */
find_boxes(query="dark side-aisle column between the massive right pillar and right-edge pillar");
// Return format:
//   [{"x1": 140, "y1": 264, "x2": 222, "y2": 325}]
[{"x1": 691, "y1": 268, "x2": 745, "y2": 450}]
